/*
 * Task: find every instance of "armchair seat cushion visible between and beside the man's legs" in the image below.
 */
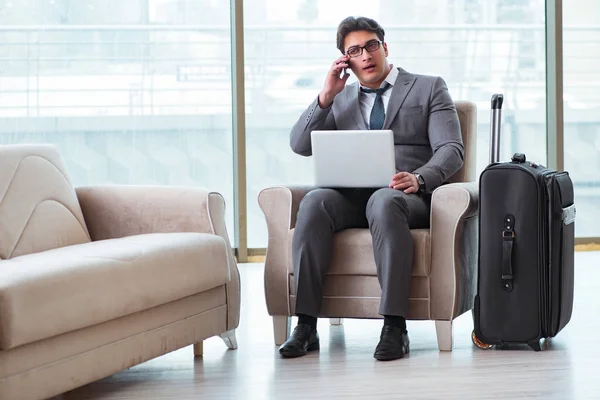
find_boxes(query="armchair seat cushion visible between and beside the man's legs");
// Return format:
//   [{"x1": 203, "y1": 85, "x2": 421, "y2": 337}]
[{"x1": 288, "y1": 229, "x2": 431, "y2": 277}]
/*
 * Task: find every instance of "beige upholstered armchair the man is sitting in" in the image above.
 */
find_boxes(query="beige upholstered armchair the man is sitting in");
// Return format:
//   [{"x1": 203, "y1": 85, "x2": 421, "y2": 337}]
[{"x1": 258, "y1": 101, "x2": 478, "y2": 351}]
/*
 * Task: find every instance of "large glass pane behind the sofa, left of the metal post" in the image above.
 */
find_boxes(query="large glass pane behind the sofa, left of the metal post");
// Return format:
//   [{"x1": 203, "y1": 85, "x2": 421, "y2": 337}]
[{"x1": 0, "y1": 0, "x2": 233, "y2": 241}]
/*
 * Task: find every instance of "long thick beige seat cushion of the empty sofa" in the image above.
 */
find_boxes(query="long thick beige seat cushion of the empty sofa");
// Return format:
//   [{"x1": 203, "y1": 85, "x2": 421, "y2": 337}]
[{"x1": 0, "y1": 233, "x2": 230, "y2": 350}]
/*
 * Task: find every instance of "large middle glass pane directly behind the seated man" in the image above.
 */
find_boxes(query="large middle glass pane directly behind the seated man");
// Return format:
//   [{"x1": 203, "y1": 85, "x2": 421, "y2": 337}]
[{"x1": 245, "y1": 0, "x2": 546, "y2": 247}]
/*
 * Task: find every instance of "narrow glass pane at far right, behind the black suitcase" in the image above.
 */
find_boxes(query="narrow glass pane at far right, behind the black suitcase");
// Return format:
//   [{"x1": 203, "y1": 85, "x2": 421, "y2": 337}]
[{"x1": 563, "y1": 0, "x2": 600, "y2": 237}]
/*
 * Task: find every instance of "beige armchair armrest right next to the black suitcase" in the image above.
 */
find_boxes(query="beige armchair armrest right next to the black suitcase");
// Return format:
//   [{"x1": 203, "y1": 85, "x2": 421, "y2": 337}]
[{"x1": 430, "y1": 182, "x2": 479, "y2": 321}]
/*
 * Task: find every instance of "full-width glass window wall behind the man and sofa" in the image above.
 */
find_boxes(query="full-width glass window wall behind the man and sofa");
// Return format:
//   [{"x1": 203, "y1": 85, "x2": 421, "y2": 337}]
[{"x1": 0, "y1": 0, "x2": 600, "y2": 252}]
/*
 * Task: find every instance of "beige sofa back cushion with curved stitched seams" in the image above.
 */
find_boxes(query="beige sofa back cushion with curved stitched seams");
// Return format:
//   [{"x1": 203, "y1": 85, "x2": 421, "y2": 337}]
[{"x1": 0, "y1": 144, "x2": 90, "y2": 259}]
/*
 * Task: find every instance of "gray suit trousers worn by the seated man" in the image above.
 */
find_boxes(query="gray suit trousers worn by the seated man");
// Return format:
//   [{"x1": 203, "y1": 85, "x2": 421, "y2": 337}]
[{"x1": 292, "y1": 188, "x2": 430, "y2": 318}]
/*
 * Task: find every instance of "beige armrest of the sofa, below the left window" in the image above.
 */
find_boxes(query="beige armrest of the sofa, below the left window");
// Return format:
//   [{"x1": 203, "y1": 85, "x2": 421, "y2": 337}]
[{"x1": 75, "y1": 185, "x2": 240, "y2": 329}]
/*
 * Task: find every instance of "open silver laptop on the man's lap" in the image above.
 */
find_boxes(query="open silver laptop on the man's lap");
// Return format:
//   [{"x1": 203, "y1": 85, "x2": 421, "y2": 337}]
[{"x1": 311, "y1": 130, "x2": 396, "y2": 188}]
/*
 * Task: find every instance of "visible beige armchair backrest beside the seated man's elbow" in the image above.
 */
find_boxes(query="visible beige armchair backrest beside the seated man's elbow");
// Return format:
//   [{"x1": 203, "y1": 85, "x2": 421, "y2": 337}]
[{"x1": 449, "y1": 100, "x2": 477, "y2": 182}]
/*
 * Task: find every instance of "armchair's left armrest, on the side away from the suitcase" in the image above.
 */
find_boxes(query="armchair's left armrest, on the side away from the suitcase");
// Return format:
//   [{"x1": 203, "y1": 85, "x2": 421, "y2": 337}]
[{"x1": 258, "y1": 186, "x2": 314, "y2": 315}]
